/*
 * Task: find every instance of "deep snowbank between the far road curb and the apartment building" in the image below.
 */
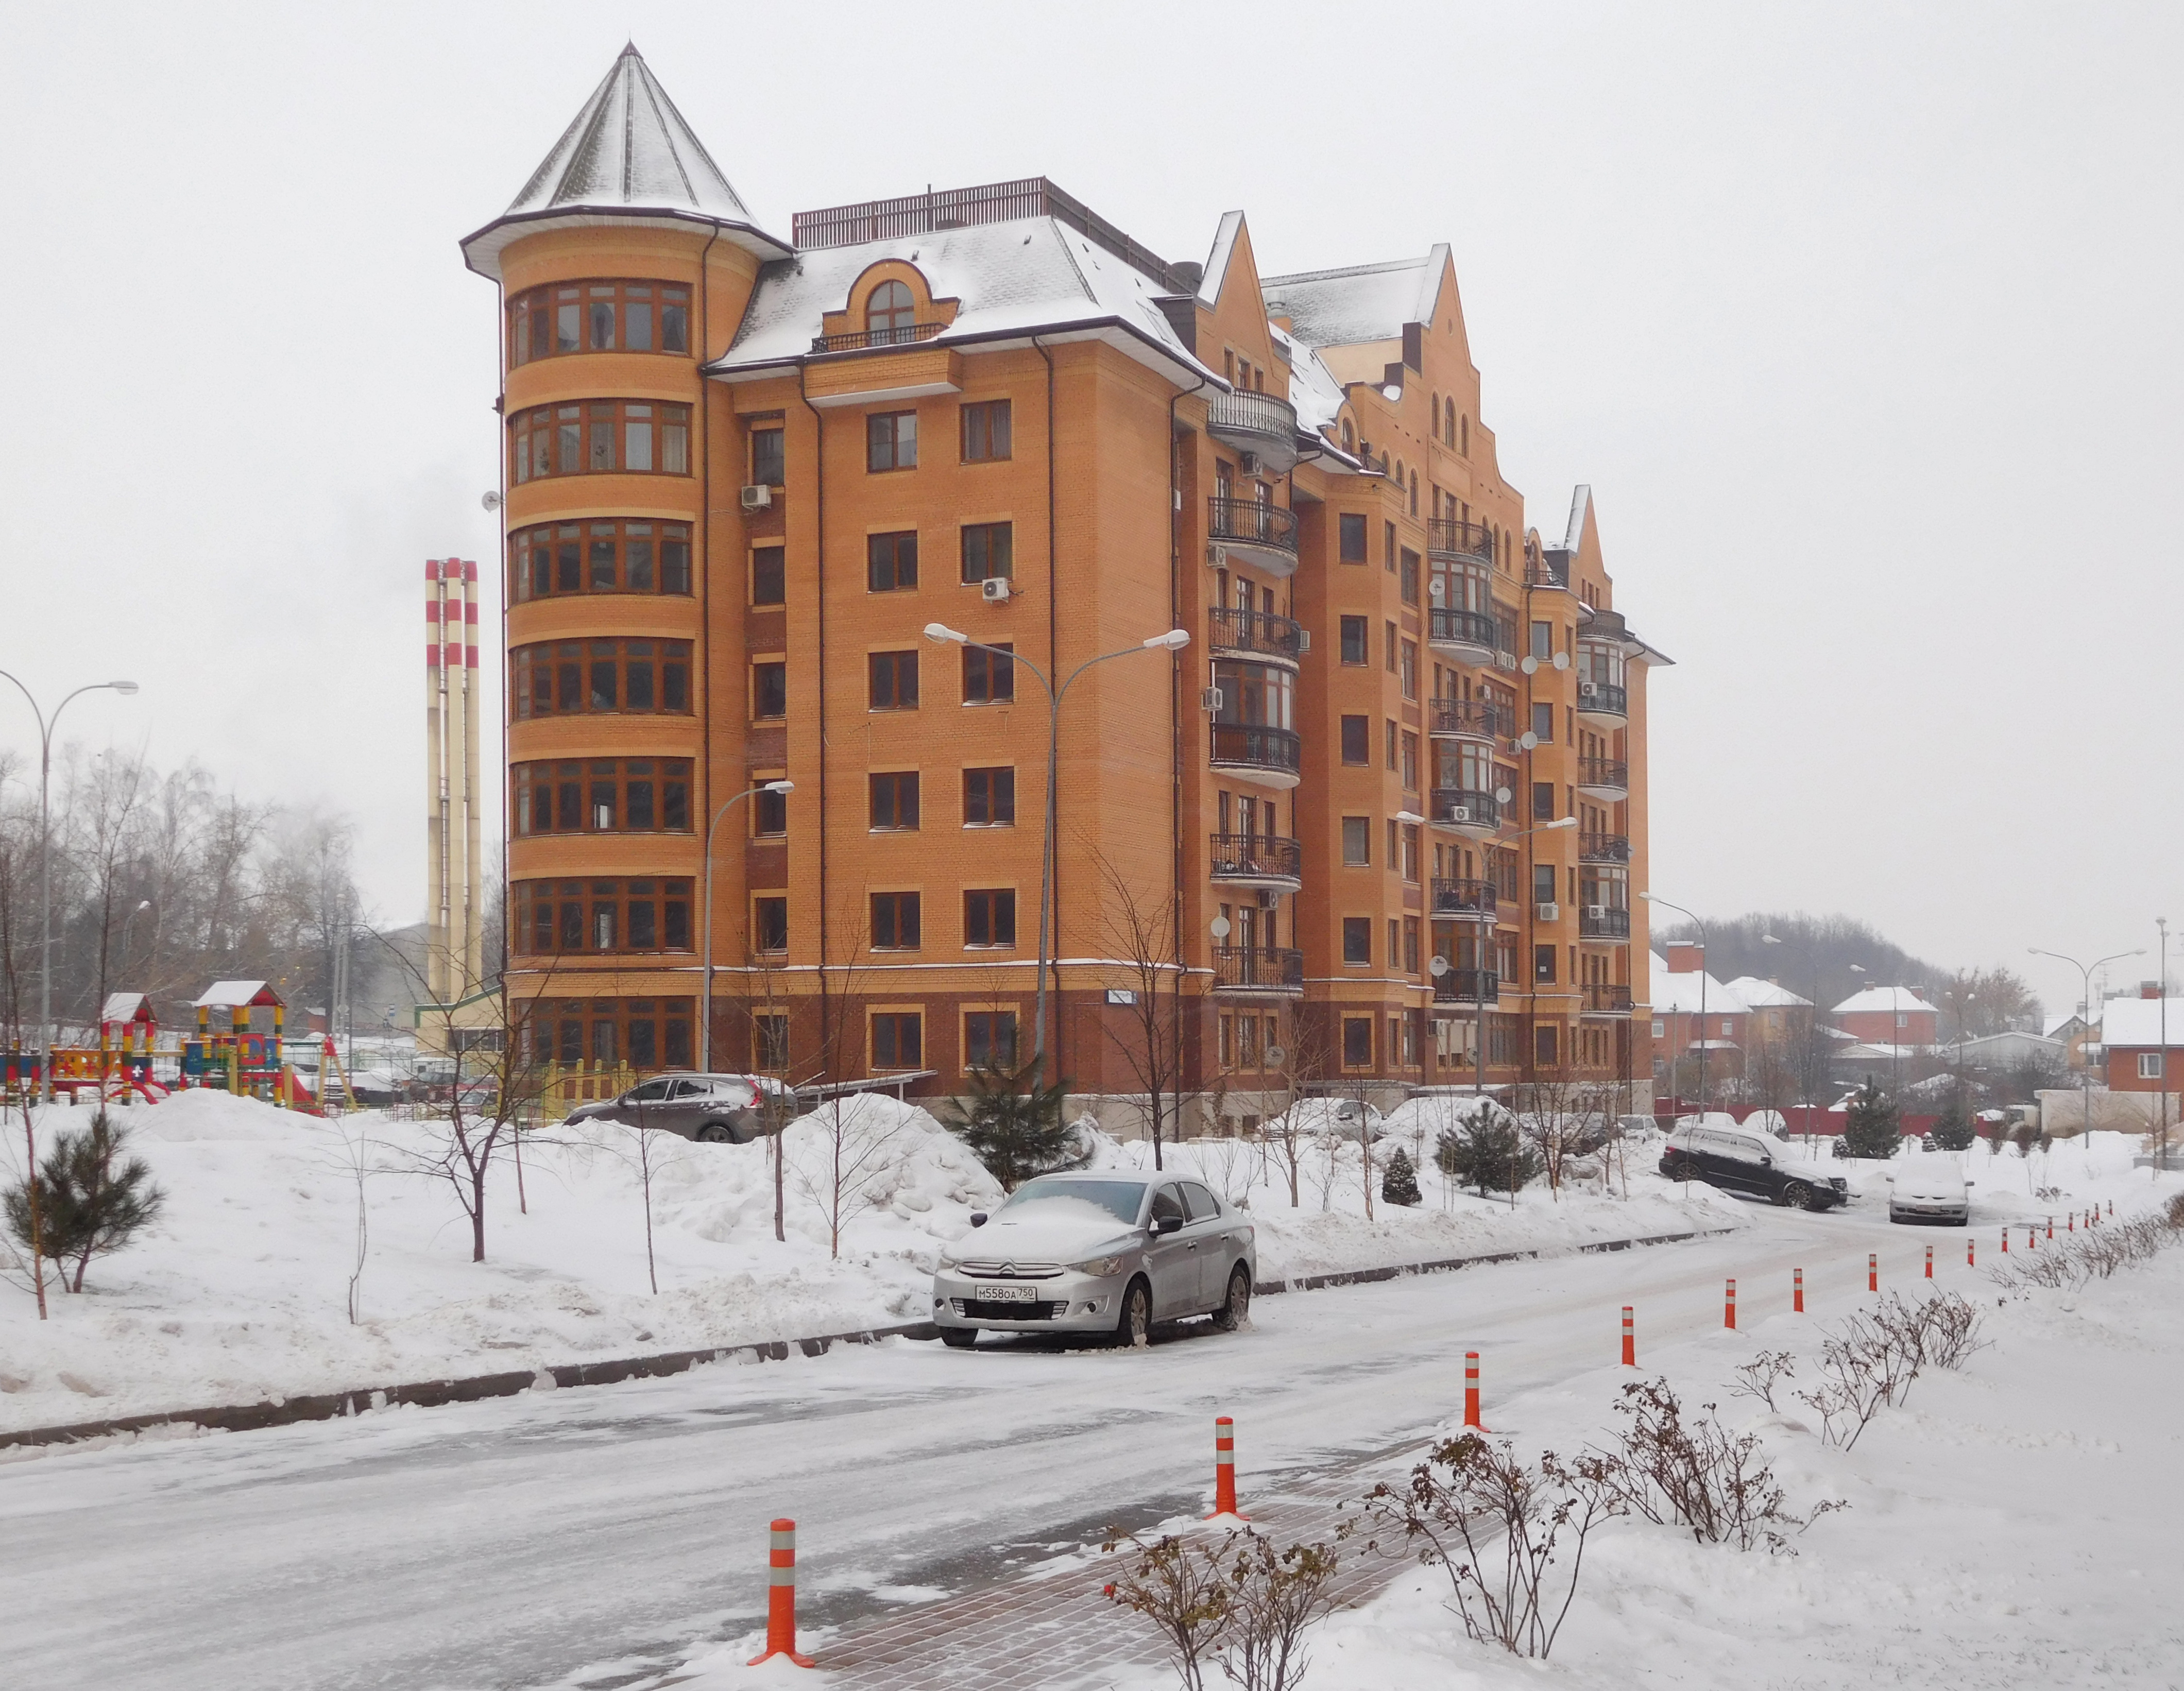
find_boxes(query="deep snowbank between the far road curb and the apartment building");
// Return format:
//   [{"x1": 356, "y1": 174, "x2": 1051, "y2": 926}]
[{"x1": 0, "y1": 1092, "x2": 1745, "y2": 1433}]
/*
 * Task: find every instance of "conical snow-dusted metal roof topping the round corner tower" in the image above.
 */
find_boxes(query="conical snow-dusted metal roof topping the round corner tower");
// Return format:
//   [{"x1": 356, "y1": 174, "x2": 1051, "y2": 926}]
[{"x1": 463, "y1": 46, "x2": 789, "y2": 275}]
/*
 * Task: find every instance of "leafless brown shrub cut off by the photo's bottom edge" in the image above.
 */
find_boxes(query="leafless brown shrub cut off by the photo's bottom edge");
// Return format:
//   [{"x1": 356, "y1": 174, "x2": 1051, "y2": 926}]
[{"x1": 1103, "y1": 1527, "x2": 1337, "y2": 1691}]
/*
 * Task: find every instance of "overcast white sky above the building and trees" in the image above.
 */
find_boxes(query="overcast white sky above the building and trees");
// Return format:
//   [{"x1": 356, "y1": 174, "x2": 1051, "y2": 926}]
[{"x1": 0, "y1": 0, "x2": 2184, "y2": 1007}]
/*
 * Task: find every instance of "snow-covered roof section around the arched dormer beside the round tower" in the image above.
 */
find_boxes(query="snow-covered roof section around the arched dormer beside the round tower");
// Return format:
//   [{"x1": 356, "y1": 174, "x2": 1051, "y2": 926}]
[{"x1": 708, "y1": 216, "x2": 1227, "y2": 389}]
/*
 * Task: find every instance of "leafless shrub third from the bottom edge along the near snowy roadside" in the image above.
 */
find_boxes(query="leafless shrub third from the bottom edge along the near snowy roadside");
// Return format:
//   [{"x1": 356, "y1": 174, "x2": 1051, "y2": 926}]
[{"x1": 1590, "y1": 1380, "x2": 1844, "y2": 1553}]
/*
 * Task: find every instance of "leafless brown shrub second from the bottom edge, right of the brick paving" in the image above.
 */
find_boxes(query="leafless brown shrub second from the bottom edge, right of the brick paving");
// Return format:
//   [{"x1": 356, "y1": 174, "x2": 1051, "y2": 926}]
[{"x1": 1343, "y1": 1433, "x2": 1625, "y2": 1658}]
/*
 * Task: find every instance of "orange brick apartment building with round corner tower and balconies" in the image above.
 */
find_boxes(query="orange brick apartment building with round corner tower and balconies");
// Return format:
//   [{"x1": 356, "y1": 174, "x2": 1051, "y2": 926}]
[{"x1": 463, "y1": 50, "x2": 1664, "y2": 1116}]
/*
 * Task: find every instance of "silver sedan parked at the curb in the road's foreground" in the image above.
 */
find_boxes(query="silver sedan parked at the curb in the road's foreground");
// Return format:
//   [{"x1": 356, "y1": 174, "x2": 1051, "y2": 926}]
[{"x1": 932, "y1": 1169, "x2": 1258, "y2": 1346}]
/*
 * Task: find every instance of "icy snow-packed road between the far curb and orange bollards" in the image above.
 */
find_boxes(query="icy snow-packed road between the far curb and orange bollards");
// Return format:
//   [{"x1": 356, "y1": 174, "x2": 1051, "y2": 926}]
[{"x1": 0, "y1": 1200, "x2": 1931, "y2": 1691}]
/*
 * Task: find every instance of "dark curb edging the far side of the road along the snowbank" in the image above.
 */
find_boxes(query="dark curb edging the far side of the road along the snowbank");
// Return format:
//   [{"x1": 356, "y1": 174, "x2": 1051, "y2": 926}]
[{"x1": 0, "y1": 1228, "x2": 1734, "y2": 1450}]
